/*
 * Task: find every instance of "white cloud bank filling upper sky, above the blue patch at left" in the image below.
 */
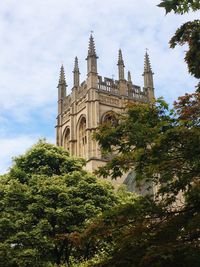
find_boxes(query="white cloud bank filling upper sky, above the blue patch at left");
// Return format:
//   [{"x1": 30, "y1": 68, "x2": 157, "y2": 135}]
[{"x1": 0, "y1": 0, "x2": 198, "y2": 114}]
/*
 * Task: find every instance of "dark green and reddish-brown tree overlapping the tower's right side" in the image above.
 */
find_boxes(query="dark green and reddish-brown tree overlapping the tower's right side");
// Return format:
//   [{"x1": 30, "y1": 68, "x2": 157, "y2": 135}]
[{"x1": 89, "y1": 92, "x2": 200, "y2": 267}]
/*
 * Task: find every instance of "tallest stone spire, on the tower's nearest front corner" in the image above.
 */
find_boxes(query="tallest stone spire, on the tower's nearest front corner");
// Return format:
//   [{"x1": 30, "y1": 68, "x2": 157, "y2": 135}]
[{"x1": 86, "y1": 34, "x2": 98, "y2": 74}]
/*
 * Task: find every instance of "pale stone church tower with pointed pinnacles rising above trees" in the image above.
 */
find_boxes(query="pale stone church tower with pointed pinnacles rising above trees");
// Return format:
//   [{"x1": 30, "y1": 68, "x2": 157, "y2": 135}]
[{"x1": 56, "y1": 35, "x2": 154, "y2": 178}]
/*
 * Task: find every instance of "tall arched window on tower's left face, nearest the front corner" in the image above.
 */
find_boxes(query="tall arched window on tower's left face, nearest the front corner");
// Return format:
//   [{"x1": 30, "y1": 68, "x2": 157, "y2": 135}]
[{"x1": 79, "y1": 117, "x2": 87, "y2": 157}]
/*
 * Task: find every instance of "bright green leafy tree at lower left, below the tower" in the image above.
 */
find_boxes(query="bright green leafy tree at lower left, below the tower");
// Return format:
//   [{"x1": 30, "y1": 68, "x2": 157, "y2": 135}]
[{"x1": 0, "y1": 141, "x2": 117, "y2": 267}]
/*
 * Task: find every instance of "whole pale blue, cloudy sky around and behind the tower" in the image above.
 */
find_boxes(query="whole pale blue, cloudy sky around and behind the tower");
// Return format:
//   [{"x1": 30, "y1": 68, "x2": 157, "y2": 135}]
[{"x1": 0, "y1": 0, "x2": 200, "y2": 174}]
